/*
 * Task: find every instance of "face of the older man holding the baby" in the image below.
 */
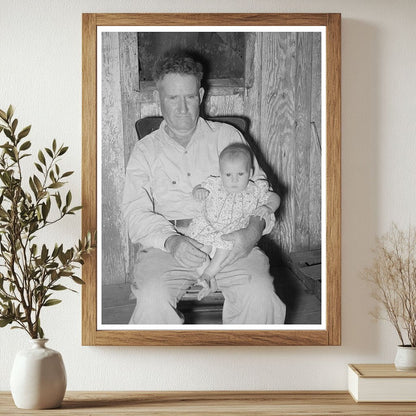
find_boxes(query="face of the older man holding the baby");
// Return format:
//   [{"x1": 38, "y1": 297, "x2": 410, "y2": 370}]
[{"x1": 157, "y1": 74, "x2": 204, "y2": 138}]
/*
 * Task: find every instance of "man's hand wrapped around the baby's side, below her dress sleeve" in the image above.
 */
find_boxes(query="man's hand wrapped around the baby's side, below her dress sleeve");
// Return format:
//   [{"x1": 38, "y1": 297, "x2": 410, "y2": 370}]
[{"x1": 221, "y1": 217, "x2": 265, "y2": 268}]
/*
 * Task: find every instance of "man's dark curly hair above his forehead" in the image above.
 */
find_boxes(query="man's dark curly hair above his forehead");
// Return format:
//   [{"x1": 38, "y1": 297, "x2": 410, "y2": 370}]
[{"x1": 152, "y1": 50, "x2": 203, "y2": 85}]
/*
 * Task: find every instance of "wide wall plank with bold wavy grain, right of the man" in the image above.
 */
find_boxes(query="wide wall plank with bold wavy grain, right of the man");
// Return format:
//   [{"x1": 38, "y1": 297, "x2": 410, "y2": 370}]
[{"x1": 260, "y1": 33, "x2": 296, "y2": 260}]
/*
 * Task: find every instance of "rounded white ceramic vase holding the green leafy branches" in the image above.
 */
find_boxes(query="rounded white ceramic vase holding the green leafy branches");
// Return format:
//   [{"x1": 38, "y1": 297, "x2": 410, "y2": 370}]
[{"x1": 10, "y1": 339, "x2": 66, "y2": 409}]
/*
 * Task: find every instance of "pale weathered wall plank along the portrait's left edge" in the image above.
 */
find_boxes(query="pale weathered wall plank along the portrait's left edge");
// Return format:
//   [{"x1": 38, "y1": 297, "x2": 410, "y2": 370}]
[{"x1": 101, "y1": 32, "x2": 126, "y2": 284}]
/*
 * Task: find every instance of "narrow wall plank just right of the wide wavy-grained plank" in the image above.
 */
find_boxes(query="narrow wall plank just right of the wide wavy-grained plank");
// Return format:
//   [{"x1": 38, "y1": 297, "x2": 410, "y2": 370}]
[{"x1": 294, "y1": 32, "x2": 312, "y2": 251}]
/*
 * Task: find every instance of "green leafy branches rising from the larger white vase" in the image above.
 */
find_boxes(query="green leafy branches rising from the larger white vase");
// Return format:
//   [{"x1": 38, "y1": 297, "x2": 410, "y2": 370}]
[{"x1": 0, "y1": 106, "x2": 93, "y2": 338}]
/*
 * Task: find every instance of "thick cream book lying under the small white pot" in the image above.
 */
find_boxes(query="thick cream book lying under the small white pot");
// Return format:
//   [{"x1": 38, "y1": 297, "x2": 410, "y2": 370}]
[{"x1": 348, "y1": 364, "x2": 416, "y2": 402}]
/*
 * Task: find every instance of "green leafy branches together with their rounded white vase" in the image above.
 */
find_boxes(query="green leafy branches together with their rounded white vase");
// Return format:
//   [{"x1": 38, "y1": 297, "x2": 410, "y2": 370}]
[{"x1": 0, "y1": 106, "x2": 93, "y2": 408}]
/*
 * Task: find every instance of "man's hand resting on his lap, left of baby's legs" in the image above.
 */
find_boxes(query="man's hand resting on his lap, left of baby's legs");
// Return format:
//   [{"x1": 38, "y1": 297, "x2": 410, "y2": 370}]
[{"x1": 165, "y1": 235, "x2": 207, "y2": 269}]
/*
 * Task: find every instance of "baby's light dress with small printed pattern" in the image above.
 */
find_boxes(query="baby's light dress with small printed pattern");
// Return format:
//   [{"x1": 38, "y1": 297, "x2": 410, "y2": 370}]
[{"x1": 186, "y1": 176, "x2": 275, "y2": 250}]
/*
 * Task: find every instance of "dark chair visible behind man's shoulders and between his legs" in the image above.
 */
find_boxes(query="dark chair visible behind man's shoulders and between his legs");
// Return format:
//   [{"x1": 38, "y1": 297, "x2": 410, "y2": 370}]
[{"x1": 135, "y1": 116, "x2": 248, "y2": 324}]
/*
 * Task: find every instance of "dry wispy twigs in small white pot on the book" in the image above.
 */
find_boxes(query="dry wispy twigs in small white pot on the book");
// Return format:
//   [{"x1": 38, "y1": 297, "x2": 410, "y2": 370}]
[{"x1": 363, "y1": 224, "x2": 416, "y2": 370}]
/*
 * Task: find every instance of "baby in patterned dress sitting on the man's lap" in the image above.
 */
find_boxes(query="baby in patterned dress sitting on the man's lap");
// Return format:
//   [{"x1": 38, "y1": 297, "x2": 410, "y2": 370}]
[{"x1": 186, "y1": 143, "x2": 280, "y2": 300}]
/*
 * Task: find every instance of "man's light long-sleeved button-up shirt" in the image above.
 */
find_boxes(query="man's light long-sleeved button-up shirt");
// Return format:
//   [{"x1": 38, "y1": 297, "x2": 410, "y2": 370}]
[{"x1": 122, "y1": 118, "x2": 270, "y2": 250}]
